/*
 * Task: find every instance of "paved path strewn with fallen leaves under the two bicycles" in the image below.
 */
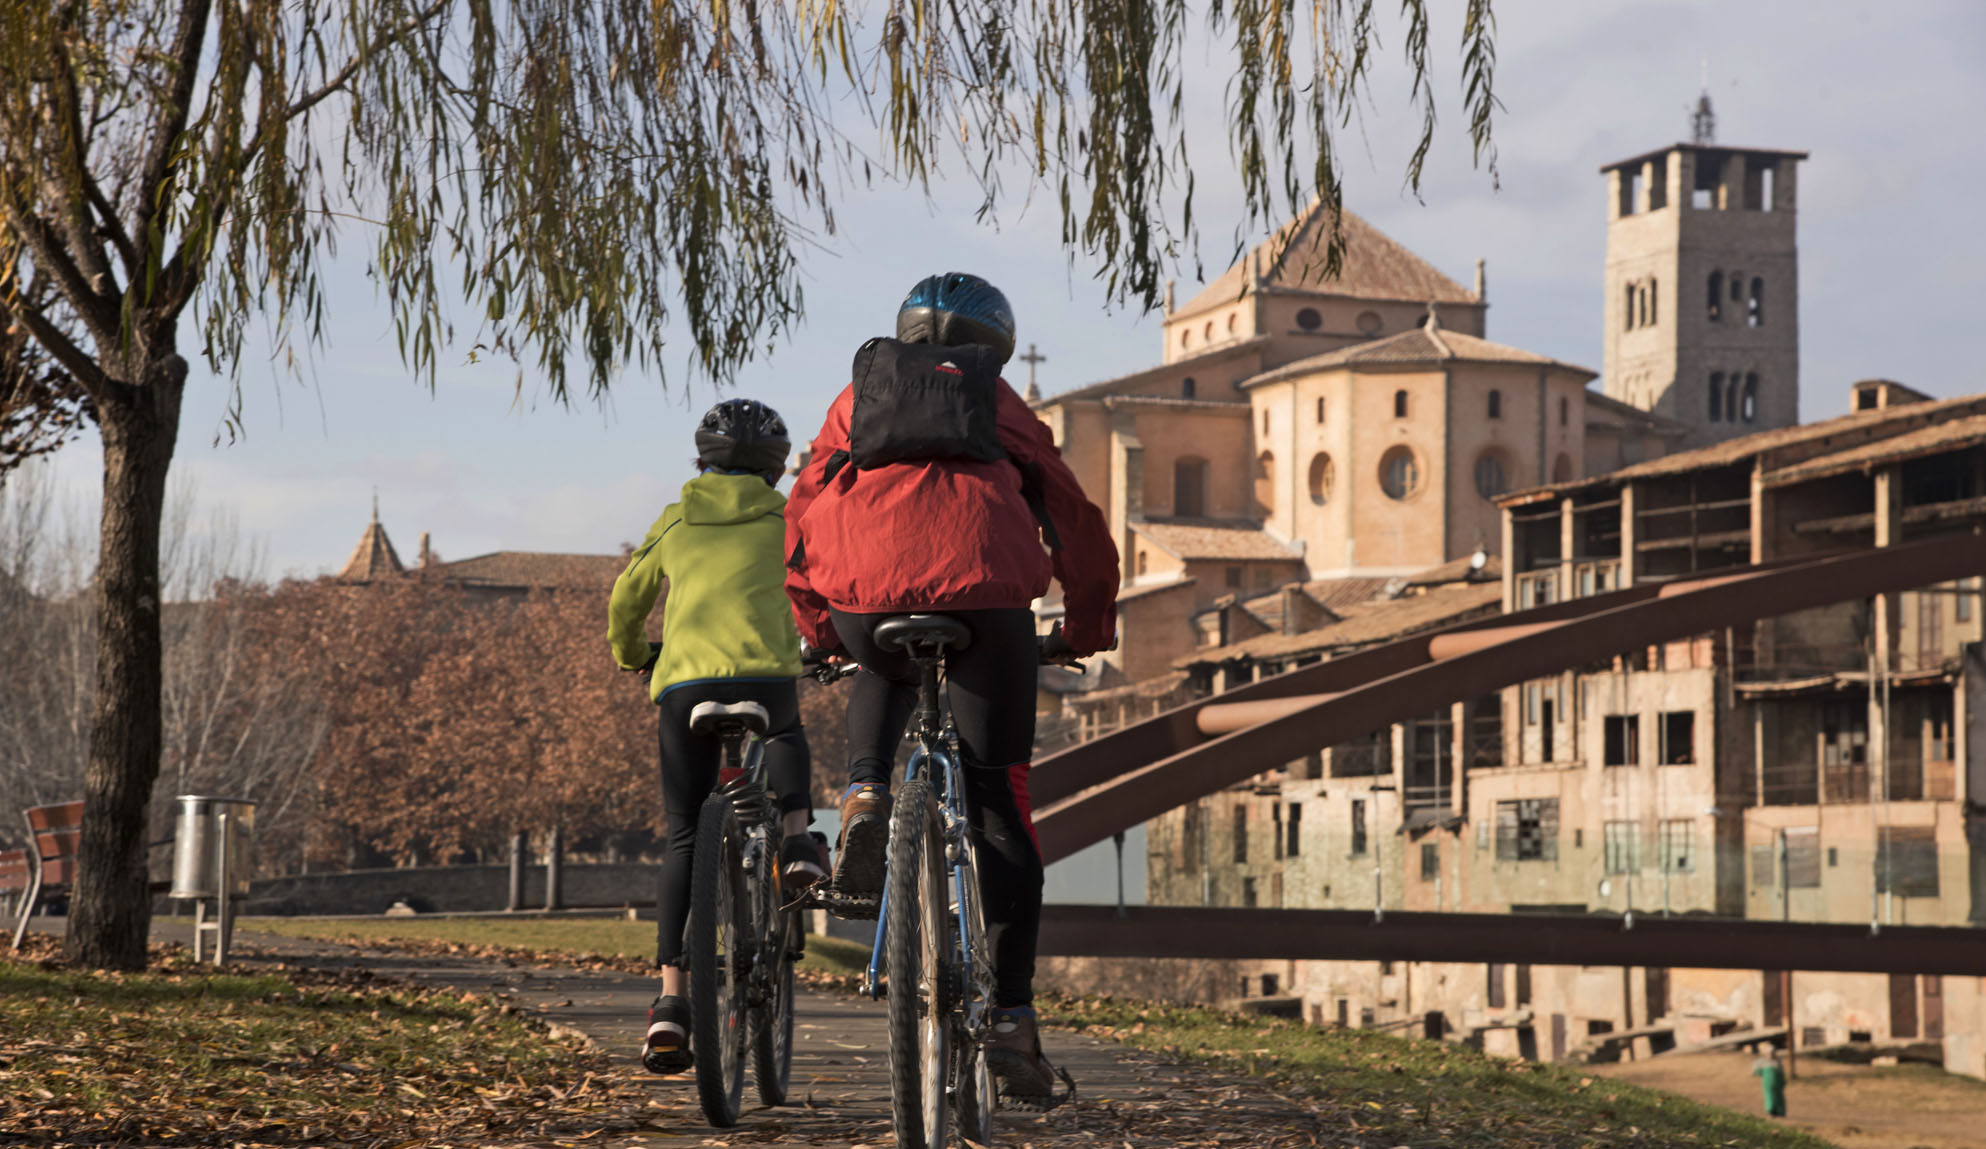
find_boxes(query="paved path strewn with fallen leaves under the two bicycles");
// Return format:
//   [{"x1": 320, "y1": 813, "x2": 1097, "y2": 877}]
[{"x1": 140, "y1": 923, "x2": 1366, "y2": 1149}]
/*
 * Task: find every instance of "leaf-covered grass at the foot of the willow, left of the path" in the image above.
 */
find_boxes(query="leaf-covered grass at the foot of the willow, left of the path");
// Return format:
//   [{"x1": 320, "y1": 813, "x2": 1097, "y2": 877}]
[{"x1": 0, "y1": 943, "x2": 647, "y2": 1145}]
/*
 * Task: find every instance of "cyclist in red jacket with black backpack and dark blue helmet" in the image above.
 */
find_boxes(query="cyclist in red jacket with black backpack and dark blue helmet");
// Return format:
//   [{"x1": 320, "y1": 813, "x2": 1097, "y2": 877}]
[{"x1": 786, "y1": 272, "x2": 1120, "y2": 1099}]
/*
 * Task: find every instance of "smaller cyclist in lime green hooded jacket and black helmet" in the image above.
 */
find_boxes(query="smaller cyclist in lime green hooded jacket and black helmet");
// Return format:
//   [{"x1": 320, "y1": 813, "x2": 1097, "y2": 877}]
[{"x1": 608, "y1": 399, "x2": 828, "y2": 1074}]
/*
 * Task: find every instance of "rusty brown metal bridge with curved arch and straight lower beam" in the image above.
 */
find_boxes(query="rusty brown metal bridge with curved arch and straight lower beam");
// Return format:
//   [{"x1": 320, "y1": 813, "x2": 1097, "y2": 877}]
[{"x1": 1033, "y1": 534, "x2": 1986, "y2": 974}]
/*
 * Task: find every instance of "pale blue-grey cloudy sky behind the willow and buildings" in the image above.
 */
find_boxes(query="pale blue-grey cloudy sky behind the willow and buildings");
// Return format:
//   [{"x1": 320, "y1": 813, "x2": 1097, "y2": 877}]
[{"x1": 27, "y1": 0, "x2": 1986, "y2": 577}]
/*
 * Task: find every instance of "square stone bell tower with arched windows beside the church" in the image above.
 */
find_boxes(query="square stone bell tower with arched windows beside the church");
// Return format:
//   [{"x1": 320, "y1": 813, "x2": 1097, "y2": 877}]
[{"x1": 1601, "y1": 93, "x2": 1807, "y2": 448}]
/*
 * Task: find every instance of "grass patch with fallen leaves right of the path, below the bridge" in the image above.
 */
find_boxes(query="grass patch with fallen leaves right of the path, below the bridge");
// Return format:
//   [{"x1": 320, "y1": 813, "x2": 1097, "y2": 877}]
[{"x1": 1041, "y1": 998, "x2": 1829, "y2": 1149}]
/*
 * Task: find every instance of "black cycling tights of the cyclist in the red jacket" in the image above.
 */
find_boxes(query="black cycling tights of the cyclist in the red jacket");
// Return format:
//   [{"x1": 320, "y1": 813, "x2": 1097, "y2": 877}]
[{"x1": 832, "y1": 607, "x2": 1041, "y2": 1006}]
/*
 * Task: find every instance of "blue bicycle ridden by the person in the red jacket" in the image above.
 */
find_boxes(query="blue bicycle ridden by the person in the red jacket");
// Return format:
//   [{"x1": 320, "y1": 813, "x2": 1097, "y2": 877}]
[{"x1": 864, "y1": 615, "x2": 1074, "y2": 1149}]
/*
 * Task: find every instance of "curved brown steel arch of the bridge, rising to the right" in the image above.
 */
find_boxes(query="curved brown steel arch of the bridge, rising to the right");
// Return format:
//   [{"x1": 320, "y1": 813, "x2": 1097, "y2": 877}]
[{"x1": 1035, "y1": 534, "x2": 1986, "y2": 863}]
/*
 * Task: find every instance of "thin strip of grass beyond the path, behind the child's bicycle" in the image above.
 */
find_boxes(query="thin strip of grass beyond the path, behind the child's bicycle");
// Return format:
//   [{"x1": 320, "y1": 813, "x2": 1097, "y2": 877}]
[{"x1": 238, "y1": 917, "x2": 870, "y2": 980}]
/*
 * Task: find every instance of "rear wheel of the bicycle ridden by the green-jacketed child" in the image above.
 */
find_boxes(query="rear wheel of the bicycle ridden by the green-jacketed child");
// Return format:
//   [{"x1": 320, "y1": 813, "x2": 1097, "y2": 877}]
[{"x1": 683, "y1": 794, "x2": 751, "y2": 1129}]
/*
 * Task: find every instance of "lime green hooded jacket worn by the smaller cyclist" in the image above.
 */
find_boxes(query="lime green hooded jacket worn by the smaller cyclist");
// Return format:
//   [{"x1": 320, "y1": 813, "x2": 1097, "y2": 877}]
[{"x1": 608, "y1": 470, "x2": 800, "y2": 699}]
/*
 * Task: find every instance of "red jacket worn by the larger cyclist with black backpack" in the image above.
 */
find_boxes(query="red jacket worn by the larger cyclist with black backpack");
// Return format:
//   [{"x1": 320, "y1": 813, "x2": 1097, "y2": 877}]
[{"x1": 786, "y1": 381, "x2": 1118, "y2": 655}]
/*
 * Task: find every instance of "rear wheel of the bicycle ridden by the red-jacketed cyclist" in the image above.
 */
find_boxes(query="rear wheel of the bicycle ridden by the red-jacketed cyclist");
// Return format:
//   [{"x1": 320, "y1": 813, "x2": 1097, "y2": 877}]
[{"x1": 884, "y1": 780, "x2": 951, "y2": 1149}]
